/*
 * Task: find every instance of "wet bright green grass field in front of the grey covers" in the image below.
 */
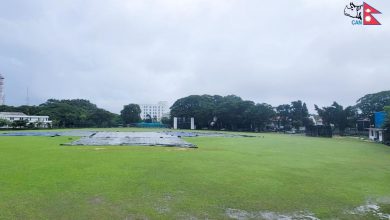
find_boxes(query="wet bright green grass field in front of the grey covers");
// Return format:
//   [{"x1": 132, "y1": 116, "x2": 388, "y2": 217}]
[{"x1": 0, "y1": 130, "x2": 390, "y2": 219}]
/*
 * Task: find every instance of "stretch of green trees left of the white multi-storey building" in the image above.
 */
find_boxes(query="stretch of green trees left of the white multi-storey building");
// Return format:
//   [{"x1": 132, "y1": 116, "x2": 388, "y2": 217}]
[{"x1": 0, "y1": 99, "x2": 152, "y2": 128}]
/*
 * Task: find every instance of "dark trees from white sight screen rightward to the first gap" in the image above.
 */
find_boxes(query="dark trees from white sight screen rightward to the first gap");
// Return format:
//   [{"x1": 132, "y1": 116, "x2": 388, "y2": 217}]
[{"x1": 171, "y1": 95, "x2": 312, "y2": 131}]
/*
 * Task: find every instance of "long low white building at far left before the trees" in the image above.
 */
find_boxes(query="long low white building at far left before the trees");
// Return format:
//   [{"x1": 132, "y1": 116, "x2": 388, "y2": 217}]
[{"x1": 0, "y1": 112, "x2": 52, "y2": 128}]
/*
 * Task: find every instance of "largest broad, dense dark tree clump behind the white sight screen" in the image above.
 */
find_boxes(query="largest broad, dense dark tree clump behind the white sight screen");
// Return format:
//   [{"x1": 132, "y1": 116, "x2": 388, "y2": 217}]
[{"x1": 171, "y1": 95, "x2": 275, "y2": 130}]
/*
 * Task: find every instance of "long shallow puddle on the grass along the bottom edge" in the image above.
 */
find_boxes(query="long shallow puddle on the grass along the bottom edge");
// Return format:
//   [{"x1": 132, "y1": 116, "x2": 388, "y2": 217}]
[{"x1": 225, "y1": 208, "x2": 319, "y2": 220}]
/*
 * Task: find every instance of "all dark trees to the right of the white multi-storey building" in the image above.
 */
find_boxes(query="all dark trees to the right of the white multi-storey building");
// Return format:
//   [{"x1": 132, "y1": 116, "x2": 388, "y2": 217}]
[{"x1": 171, "y1": 91, "x2": 390, "y2": 134}]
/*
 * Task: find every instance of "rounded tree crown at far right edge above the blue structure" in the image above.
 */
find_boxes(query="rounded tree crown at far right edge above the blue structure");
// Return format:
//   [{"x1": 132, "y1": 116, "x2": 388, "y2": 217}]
[{"x1": 355, "y1": 90, "x2": 390, "y2": 118}]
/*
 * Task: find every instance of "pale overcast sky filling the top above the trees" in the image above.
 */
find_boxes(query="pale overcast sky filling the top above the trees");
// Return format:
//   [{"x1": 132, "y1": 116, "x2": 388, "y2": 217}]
[{"x1": 0, "y1": 0, "x2": 390, "y2": 112}]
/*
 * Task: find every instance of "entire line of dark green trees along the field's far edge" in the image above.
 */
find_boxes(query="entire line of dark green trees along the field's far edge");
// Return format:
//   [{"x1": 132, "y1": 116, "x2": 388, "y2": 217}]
[{"x1": 0, "y1": 91, "x2": 390, "y2": 132}]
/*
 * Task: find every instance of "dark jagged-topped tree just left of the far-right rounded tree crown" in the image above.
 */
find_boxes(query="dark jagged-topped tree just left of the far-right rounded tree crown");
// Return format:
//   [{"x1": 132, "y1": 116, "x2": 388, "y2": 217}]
[{"x1": 315, "y1": 102, "x2": 358, "y2": 135}]
